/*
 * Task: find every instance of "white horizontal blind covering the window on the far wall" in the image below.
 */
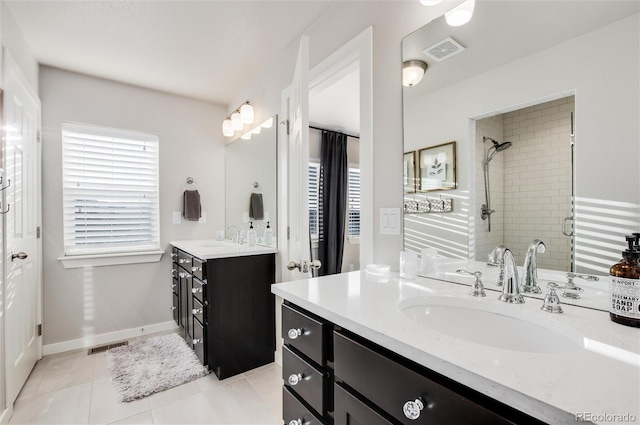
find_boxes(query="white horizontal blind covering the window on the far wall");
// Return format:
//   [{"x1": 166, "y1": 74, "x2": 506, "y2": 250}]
[{"x1": 62, "y1": 123, "x2": 160, "y2": 256}]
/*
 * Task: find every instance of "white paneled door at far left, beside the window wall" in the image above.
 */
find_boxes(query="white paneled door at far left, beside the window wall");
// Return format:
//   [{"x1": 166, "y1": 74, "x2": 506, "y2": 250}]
[{"x1": 2, "y1": 49, "x2": 42, "y2": 406}]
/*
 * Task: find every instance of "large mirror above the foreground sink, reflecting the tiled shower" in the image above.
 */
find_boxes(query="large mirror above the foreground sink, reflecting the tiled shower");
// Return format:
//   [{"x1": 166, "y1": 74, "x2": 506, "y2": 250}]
[{"x1": 402, "y1": 0, "x2": 640, "y2": 275}]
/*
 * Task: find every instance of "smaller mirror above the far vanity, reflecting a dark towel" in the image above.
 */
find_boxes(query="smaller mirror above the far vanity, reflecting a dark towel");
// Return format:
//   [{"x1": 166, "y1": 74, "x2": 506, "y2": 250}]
[{"x1": 225, "y1": 115, "x2": 278, "y2": 247}]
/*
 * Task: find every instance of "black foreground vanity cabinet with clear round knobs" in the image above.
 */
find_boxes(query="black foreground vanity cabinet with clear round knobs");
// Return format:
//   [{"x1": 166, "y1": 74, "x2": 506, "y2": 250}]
[{"x1": 282, "y1": 301, "x2": 543, "y2": 425}]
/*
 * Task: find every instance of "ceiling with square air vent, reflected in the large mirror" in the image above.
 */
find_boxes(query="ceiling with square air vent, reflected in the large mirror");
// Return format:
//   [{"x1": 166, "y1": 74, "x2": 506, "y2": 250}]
[{"x1": 402, "y1": 0, "x2": 640, "y2": 99}]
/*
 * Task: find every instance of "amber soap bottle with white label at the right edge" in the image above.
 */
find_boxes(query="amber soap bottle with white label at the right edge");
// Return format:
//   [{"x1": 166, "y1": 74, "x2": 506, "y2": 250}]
[{"x1": 609, "y1": 234, "x2": 640, "y2": 328}]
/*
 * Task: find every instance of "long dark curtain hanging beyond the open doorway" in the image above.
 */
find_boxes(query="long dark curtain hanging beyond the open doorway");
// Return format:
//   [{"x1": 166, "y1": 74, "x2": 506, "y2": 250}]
[{"x1": 318, "y1": 130, "x2": 349, "y2": 276}]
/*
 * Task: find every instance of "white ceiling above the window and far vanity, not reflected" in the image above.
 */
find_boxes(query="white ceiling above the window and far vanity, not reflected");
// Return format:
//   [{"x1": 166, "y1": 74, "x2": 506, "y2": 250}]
[{"x1": 7, "y1": 0, "x2": 335, "y2": 105}]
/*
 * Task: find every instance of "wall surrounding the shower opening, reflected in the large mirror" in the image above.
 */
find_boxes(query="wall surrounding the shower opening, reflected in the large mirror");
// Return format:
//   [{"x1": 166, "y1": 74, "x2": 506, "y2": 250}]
[{"x1": 405, "y1": 14, "x2": 640, "y2": 273}]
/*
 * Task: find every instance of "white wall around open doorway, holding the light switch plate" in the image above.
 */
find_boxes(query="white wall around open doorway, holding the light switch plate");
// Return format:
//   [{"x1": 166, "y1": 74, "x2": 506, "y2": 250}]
[{"x1": 226, "y1": 1, "x2": 446, "y2": 269}]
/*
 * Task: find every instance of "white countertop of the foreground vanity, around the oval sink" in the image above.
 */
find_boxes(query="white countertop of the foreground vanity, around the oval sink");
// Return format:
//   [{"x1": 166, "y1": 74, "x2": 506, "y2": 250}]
[{"x1": 272, "y1": 271, "x2": 640, "y2": 424}]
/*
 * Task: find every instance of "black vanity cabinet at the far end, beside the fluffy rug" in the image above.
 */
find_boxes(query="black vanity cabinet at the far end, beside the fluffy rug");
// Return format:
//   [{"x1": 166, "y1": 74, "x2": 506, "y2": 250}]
[{"x1": 171, "y1": 247, "x2": 275, "y2": 379}]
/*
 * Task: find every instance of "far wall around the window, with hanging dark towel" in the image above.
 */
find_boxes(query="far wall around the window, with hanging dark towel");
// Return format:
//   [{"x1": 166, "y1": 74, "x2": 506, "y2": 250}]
[{"x1": 40, "y1": 66, "x2": 226, "y2": 353}]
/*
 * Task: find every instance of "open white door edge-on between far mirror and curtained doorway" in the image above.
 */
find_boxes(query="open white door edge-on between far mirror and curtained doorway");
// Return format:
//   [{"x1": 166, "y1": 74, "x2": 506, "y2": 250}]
[{"x1": 279, "y1": 36, "x2": 311, "y2": 281}]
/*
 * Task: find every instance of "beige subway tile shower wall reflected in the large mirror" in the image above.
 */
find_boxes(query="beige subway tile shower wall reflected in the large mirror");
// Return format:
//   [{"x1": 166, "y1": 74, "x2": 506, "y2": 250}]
[{"x1": 476, "y1": 96, "x2": 575, "y2": 270}]
